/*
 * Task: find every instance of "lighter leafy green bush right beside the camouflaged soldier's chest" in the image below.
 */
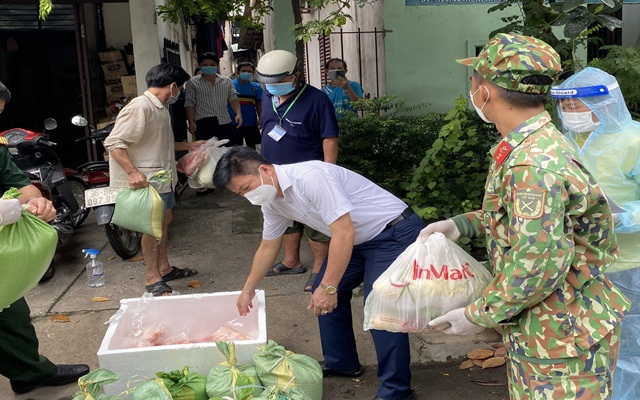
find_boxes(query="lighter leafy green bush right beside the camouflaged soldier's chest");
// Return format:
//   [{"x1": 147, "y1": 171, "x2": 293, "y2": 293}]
[{"x1": 402, "y1": 96, "x2": 499, "y2": 252}]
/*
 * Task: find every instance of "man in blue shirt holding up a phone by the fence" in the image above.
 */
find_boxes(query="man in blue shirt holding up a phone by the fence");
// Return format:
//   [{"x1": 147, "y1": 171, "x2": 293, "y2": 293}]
[{"x1": 322, "y1": 58, "x2": 364, "y2": 118}]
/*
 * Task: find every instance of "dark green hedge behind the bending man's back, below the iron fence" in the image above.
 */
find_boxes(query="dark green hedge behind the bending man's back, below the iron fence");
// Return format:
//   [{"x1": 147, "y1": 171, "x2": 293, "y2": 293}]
[{"x1": 338, "y1": 96, "x2": 444, "y2": 197}]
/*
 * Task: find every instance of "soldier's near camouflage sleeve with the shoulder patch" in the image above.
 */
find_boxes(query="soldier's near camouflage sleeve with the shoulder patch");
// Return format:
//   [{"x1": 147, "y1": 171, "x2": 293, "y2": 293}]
[{"x1": 465, "y1": 166, "x2": 588, "y2": 327}]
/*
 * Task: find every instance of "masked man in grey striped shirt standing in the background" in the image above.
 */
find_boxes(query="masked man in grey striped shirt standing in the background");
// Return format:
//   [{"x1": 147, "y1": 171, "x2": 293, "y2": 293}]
[{"x1": 184, "y1": 53, "x2": 242, "y2": 146}]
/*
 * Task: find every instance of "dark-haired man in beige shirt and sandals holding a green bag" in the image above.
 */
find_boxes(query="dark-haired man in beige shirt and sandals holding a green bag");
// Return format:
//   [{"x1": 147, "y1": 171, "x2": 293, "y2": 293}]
[{"x1": 104, "y1": 64, "x2": 205, "y2": 296}]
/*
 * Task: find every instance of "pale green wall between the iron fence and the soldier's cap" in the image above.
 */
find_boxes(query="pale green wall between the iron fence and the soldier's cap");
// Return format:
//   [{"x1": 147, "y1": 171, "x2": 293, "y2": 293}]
[{"x1": 384, "y1": 1, "x2": 511, "y2": 112}]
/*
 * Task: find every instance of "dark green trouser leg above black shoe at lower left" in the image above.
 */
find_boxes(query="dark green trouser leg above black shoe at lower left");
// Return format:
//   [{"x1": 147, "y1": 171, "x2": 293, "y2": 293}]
[{"x1": 0, "y1": 297, "x2": 56, "y2": 381}]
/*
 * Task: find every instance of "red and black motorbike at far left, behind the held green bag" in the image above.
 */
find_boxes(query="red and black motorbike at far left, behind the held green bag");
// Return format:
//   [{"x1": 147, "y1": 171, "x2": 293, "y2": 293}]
[{"x1": 0, "y1": 118, "x2": 89, "y2": 282}]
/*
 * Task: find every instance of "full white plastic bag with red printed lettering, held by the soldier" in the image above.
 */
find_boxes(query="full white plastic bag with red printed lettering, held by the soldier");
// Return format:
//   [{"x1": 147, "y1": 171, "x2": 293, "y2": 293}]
[{"x1": 364, "y1": 233, "x2": 491, "y2": 332}]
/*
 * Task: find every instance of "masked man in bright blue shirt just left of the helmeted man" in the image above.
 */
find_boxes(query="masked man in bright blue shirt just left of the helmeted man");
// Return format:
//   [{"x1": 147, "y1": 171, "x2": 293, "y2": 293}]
[{"x1": 228, "y1": 62, "x2": 262, "y2": 149}]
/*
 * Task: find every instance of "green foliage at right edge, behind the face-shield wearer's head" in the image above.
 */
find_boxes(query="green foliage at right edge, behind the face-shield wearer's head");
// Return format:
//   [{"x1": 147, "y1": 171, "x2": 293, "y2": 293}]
[{"x1": 589, "y1": 46, "x2": 640, "y2": 119}]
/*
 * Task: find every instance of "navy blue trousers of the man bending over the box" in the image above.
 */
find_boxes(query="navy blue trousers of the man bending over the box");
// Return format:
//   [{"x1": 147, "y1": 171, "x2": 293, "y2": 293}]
[{"x1": 313, "y1": 214, "x2": 424, "y2": 399}]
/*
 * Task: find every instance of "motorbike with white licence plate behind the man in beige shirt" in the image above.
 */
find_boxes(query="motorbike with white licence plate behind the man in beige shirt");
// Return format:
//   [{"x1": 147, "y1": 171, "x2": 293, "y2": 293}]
[{"x1": 71, "y1": 115, "x2": 140, "y2": 259}]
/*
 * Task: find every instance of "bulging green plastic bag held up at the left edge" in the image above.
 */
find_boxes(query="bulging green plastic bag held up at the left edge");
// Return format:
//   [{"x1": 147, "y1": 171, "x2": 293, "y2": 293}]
[{"x1": 0, "y1": 188, "x2": 58, "y2": 310}]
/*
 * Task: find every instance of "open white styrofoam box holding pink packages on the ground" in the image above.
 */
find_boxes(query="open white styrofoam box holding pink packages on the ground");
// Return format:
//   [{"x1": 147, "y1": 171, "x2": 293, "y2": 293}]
[{"x1": 98, "y1": 290, "x2": 267, "y2": 395}]
